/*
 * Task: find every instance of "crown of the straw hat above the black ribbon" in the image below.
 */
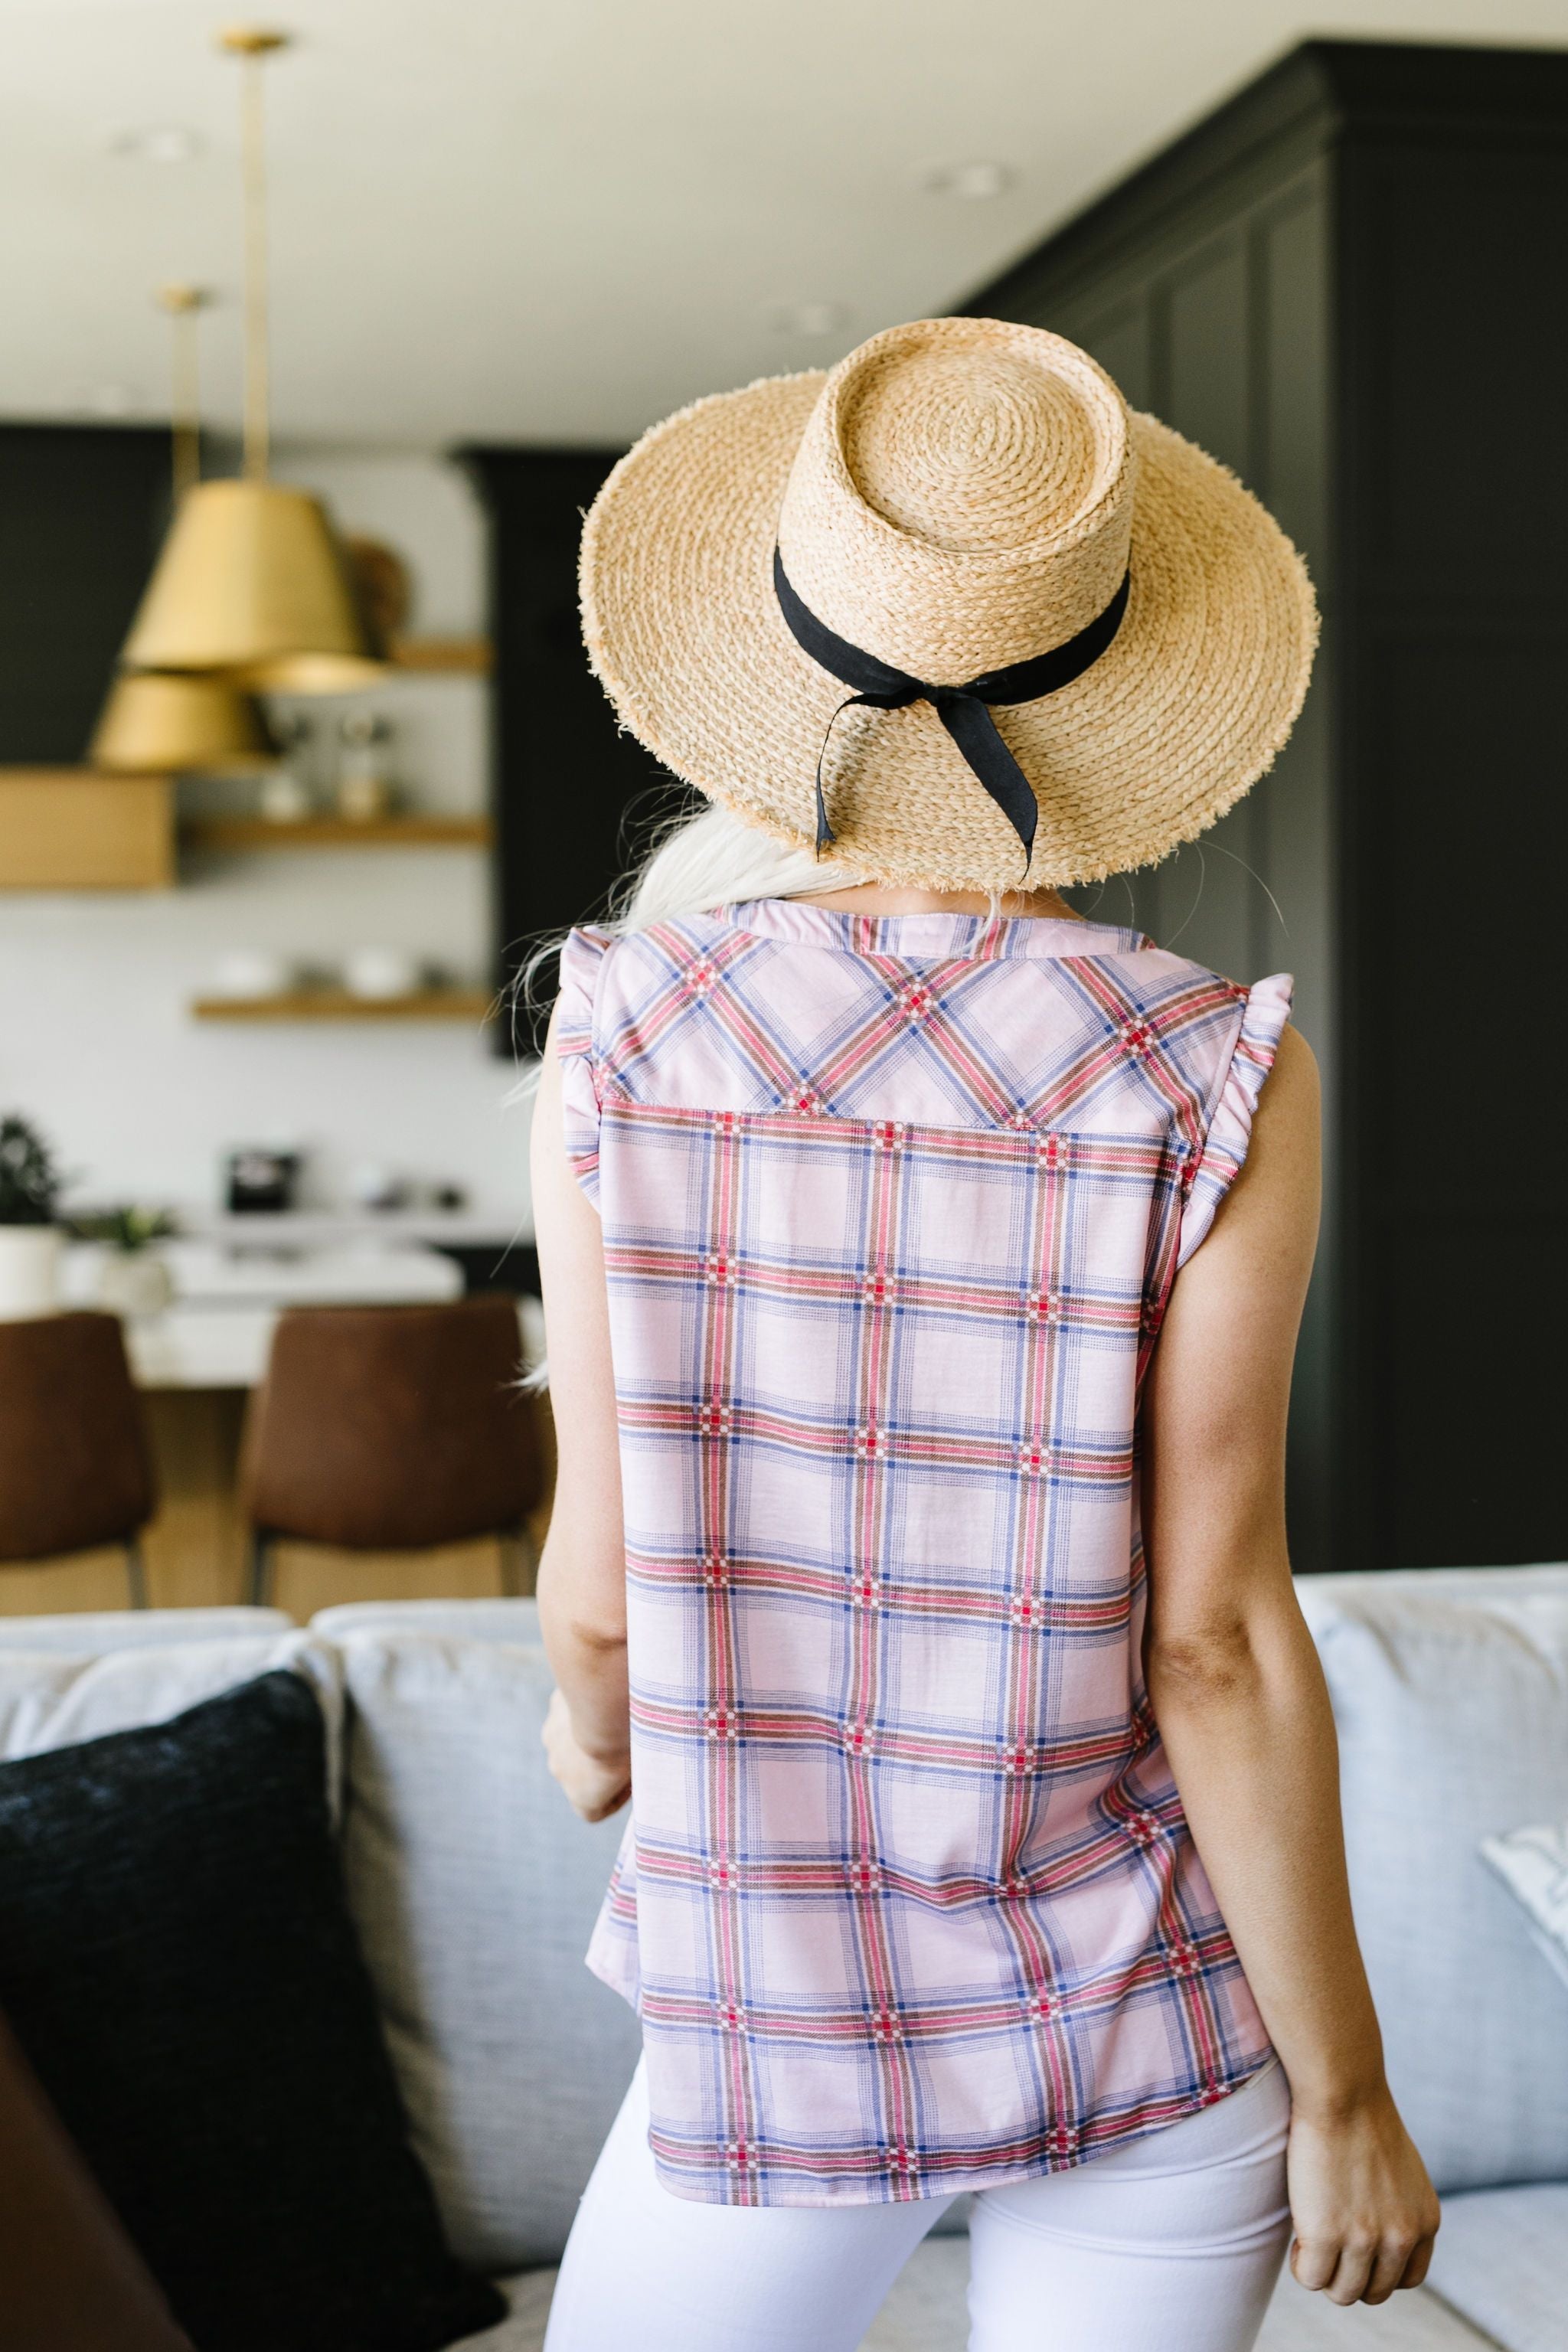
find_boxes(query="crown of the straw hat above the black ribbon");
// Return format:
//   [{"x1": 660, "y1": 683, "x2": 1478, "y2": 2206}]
[{"x1": 778, "y1": 318, "x2": 1133, "y2": 684}]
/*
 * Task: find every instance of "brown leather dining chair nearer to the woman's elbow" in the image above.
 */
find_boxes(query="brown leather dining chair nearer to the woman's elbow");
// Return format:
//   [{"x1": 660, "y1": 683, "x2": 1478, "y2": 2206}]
[{"x1": 240, "y1": 1294, "x2": 543, "y2": 1602}]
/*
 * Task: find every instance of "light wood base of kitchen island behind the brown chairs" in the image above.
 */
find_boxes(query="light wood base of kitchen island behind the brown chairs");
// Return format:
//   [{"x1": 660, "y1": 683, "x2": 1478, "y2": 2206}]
[{"x1": 0, "y1": 1387, "x2": 555, "y2": 1623}]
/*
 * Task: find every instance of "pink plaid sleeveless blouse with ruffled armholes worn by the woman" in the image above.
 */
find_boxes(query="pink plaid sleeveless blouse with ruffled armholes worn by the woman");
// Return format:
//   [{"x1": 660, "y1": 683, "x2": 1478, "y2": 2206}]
[{"x1": 557, "y1": 901, "x2": 1291, "y2": 2207}]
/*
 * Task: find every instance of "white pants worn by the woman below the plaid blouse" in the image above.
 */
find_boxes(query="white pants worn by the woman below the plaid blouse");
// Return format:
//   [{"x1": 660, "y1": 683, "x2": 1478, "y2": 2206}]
[{"x1": 545, "y1": 2065, "x2": 1291, "y2": 2352}]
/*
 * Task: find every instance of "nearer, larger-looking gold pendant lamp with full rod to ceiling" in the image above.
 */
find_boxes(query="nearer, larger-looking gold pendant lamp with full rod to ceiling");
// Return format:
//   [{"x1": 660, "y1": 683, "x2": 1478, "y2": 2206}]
[{"x1": 122, "y1": 26, "x2": 383, "y2": 694}]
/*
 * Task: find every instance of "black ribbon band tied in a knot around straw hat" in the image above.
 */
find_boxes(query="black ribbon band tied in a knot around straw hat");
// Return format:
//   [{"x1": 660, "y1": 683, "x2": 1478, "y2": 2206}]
[{"x1": 773, "y1": 548, "x2": 1133, "y2": 875}]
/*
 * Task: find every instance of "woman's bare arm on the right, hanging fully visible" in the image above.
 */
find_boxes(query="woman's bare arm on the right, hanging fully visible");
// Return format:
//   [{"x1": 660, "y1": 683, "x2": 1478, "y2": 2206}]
[{"x1": 1142, "y1": 1031, "x2": 1439, "y2": 2302}]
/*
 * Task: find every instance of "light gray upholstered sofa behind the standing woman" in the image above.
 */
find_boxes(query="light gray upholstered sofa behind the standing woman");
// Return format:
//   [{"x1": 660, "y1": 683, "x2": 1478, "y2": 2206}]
[{"x1": 0, "y1": 1566, "x2": 1568, "y2": 2352}]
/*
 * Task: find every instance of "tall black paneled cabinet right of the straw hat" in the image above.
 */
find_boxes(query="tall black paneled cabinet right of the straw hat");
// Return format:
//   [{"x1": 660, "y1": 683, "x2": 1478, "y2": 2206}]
[{"x1": 966, "y1": 42, "x2": 1568, "y2": 1569}]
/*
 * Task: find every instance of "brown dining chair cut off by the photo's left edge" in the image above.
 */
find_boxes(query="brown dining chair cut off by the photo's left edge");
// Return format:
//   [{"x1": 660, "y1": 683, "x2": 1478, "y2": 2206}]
[{"x1": 0, "y1": 1312, "x2": 158, "y2": 1609}]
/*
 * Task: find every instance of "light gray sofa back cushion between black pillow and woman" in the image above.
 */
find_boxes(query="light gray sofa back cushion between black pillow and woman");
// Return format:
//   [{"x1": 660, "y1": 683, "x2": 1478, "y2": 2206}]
[{"x1": 331, "y1": 1602, "x2": 639, "y2": 2269}]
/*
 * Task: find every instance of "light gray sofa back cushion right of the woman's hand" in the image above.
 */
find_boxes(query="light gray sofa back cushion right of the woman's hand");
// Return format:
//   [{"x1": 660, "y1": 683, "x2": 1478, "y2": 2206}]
[{"x1": 1298, "y1": 1566, "x2": 1568, "y2": 2190}]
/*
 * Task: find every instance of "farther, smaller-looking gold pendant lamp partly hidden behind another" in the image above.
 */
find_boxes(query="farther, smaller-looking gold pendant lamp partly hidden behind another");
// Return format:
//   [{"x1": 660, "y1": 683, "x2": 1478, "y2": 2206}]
[{"x1": 87, "y1": 285, "x2": 277, "y2": 776}]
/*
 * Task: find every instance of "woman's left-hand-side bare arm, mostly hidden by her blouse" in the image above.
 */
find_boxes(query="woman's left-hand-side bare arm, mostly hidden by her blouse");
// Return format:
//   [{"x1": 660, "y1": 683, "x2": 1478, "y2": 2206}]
[{"x1": 529, "y1": 1001, "x2": 630, "y2": 1821}]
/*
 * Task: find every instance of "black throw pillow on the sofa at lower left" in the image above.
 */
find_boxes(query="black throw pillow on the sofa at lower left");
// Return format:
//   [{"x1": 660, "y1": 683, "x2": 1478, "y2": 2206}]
[{"x1": 0, "y1": 1672, "x2": 503, "y2": 2352}]
